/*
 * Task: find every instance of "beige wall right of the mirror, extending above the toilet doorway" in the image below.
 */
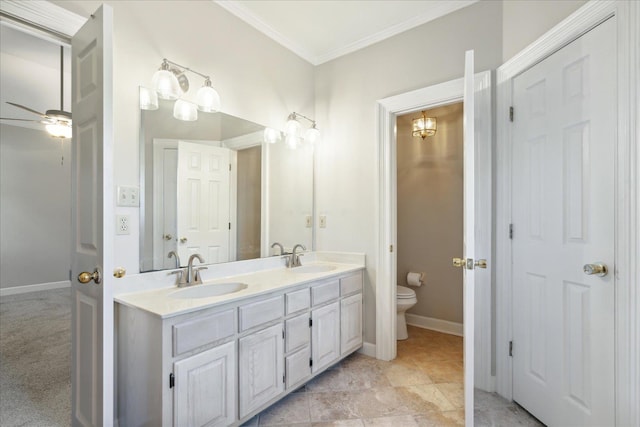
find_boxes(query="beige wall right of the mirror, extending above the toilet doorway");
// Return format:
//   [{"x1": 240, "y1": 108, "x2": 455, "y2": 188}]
[{"x1": 316, "y1": 2, "x2": 502, "y2": 343}]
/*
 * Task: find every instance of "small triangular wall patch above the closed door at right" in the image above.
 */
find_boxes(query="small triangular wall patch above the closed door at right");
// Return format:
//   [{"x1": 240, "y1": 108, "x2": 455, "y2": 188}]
[{"x1": 502, "y1": 0, "x2": 587, "y2": 61}]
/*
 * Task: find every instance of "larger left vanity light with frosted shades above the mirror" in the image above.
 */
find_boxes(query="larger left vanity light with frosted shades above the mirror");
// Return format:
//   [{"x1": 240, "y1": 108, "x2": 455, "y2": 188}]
[{"x1": 140, "y1": 58, "x2": 220, "y2": 121}]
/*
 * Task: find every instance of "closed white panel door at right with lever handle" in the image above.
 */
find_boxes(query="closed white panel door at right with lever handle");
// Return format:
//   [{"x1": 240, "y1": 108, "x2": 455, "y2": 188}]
[{"x1": 513, "y1": 18, "x2": 616, "y2": 426}]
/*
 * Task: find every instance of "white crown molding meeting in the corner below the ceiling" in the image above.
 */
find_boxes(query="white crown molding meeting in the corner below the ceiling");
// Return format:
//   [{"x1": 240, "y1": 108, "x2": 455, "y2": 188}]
[{"x1": 214, "y1": 0, "x2": 479, "y2": 65}]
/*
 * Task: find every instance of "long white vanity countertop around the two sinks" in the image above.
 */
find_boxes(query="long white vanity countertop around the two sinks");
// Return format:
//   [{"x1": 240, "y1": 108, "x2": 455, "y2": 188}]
[{"x1": 114, "y1": 262, "x2": 364, "y2": 318}]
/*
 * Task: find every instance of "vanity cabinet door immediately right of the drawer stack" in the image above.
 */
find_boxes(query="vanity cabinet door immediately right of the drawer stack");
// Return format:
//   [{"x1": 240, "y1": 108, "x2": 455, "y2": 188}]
[{"x1": 311, "y1": 301, "x2": 340, "y2": 373}]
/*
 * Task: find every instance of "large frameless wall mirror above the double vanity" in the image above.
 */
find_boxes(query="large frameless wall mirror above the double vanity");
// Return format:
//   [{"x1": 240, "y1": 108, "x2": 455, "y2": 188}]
[{"x1": 140, "y1": 95, "x2": 313, "y2": 272}]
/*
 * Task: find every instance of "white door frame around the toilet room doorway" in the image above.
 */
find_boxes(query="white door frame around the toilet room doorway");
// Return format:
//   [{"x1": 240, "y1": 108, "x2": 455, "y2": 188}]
[{"x1": 375, "y1": 71, "x2": 493, "y2": 390}]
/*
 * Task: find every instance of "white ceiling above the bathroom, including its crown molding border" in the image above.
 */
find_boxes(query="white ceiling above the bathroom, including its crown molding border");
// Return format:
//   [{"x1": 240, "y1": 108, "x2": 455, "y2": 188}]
[{"x1": 214, "y1": 0, "x2": 478, "y2": 65}]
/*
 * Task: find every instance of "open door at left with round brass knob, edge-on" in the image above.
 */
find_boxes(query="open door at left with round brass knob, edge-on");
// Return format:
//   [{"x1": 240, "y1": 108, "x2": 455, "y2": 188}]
[{"x1": 71, "y1": 5, "x2": 115, "y2": 426}]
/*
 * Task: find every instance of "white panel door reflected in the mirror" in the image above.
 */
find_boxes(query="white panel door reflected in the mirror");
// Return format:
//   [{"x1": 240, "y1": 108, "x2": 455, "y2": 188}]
[{"x1": 177, "y1": 141, "x2": 230, "y2": 263}]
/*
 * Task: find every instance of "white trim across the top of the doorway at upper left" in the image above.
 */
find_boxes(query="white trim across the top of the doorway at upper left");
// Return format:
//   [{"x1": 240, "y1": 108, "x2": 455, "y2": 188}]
[{"x1": 0, "y1": 0, "x2": 87, "y2": 39}]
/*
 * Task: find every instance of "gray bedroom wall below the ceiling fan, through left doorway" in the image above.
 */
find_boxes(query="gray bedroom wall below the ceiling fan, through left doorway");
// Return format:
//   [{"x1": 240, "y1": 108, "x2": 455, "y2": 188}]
[{"x1": 0, "y1": 124, "x2": 71, "y2": 288}]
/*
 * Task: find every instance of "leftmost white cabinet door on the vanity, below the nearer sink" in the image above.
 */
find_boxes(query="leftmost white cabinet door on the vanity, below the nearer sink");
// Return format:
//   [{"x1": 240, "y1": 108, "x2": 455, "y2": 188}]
[{"x1": 173, "y1": 342, "x2": 236, "y2": 426}]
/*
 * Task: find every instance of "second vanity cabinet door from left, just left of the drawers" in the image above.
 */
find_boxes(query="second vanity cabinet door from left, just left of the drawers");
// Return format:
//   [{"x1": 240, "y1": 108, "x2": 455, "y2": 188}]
[{"x1": 239, "y1": 324, "x2": 284, "y2": 418}]
